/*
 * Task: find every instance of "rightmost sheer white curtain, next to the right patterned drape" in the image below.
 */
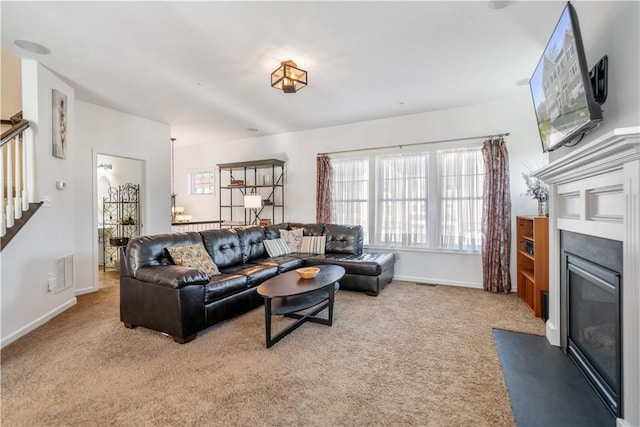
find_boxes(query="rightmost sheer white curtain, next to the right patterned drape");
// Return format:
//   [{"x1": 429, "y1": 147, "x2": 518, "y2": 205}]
[{"x1": 437, "y1": 147, "x2": 485, "y2": 251}]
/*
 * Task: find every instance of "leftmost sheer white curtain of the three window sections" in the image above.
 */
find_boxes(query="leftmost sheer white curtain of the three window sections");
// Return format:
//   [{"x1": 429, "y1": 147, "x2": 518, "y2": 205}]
[{"x1": 331, "y1": 158, "x2": 369, "y2": 244}]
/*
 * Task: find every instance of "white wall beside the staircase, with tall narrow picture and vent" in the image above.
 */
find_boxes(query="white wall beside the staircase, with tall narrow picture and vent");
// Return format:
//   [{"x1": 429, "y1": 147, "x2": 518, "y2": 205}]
[{"x1": 1, "y1": 60, "x2": 77, "y2": 346}]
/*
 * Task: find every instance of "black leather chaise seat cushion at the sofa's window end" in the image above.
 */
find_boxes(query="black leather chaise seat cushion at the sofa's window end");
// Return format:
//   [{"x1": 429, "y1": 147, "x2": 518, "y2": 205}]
[{"x1": 305, "y1": 252, "x2": 396, "y2": 276}]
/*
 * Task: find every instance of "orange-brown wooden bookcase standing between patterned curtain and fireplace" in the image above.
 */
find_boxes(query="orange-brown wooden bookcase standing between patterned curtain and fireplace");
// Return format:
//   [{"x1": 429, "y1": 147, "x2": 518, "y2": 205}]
[{"x1": 516, "y1": 216, "x2": 549, "y2": 317}]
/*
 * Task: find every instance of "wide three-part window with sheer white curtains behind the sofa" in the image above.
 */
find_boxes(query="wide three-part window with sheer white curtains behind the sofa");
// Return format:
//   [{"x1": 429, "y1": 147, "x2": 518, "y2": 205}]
[{"x1": 331, "y1": 142, "x2": 484, "y2": 251}]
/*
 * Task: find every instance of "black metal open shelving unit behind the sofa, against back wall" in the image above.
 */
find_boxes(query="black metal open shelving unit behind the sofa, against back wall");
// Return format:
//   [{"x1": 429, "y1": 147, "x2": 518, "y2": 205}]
[{"x1": 218, "y1": 159, "x2": 285, "y2": 227}]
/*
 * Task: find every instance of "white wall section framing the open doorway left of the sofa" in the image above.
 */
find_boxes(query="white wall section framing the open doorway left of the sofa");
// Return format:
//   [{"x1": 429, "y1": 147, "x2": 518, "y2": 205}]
[{"x1": 74, "y1": 101, "x2": 171, "y2": 293}]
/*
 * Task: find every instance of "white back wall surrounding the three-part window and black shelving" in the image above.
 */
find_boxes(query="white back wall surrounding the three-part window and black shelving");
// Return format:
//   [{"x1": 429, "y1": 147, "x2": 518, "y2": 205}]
[{"x1": 175, "y1": 93, "x2": 546, "y2": 288}]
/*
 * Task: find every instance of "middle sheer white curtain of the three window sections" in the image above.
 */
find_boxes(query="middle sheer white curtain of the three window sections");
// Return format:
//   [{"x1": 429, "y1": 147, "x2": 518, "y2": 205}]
[{"x1": 376, "y1": 153, "x2": 429, "y2": 247}]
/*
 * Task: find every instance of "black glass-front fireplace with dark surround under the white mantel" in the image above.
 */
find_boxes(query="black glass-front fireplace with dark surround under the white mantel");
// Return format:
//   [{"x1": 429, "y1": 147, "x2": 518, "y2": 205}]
[{"x1": 561, "y1": 232, "x2": 622, "y2": 417}]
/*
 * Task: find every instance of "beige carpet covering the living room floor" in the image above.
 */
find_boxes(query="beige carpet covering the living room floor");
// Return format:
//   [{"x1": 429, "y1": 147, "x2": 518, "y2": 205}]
[{"x1": 0, "y1": 281, "x2": 544, "y2": 427}]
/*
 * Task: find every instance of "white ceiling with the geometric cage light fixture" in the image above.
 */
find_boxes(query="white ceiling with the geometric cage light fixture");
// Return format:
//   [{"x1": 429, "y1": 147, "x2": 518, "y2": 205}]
[{"x1": 0, "y1": 1, "x2": 612, "y2": 145}]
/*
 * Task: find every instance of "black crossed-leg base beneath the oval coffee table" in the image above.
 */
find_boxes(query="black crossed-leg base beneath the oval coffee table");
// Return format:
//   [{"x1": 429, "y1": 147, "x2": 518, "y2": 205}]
[{"x1": 264, "y1": 282, "x2": 340, "y2": 348}]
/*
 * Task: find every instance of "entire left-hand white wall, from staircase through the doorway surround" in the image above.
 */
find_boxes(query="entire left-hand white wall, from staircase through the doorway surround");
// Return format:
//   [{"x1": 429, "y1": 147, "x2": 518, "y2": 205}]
[{"x1": 0, "y1": 65, "x2": 171, "y2": 346}]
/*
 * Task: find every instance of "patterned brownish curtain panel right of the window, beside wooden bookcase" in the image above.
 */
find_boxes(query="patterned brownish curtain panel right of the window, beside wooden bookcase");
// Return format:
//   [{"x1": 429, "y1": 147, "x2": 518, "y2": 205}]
[{"x1": 482, "y1": 138, "x2": 511, "y2": 293}]
